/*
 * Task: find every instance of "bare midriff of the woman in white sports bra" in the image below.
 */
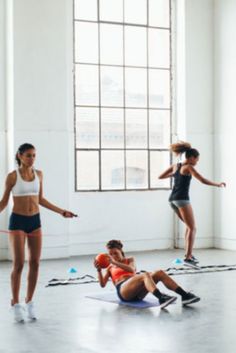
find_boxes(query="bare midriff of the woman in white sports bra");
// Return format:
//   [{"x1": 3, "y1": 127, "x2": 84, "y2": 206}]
[{"x1": 12, "y1": 195, "x2": 39, "y2": 216}]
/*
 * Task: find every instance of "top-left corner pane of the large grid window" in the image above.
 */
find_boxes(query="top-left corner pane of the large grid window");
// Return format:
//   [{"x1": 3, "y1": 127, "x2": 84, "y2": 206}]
[{"x1": 74, "y1": 0, "x2": 97, "y2": 21}]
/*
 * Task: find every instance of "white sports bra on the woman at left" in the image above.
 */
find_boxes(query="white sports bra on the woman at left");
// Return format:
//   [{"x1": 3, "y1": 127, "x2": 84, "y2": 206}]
[{"x1": 12, "y1": 169, "x2": 40, "y2": 197}]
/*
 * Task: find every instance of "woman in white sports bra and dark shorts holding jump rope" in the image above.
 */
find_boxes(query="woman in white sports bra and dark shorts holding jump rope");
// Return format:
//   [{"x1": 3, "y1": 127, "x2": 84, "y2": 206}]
[{"x1": 0, "y1": 143, "x2": 76, "y2": 322}]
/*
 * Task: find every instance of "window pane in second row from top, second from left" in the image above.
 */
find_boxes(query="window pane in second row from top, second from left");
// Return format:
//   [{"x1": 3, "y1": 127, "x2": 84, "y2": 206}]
[{"x1": 100, "y1": 24, "x2": 123, "y2": 65}]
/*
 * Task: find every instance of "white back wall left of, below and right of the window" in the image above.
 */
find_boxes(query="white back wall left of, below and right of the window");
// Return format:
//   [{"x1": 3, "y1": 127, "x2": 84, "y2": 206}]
[{"x1": 1, "y1": 0, "x2": 215, "y2": 258}]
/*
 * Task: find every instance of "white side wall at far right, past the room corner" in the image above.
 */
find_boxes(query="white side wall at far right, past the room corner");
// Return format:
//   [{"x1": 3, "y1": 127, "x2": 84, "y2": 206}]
[{"x1": 214, "y1": 0, "x2": 236, "y2": 250}]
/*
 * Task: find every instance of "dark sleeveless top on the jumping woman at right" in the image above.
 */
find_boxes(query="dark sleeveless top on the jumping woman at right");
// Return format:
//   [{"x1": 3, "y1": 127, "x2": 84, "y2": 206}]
[{"x1": 169, "y1": 163, "x2": 192, "y2": 201}]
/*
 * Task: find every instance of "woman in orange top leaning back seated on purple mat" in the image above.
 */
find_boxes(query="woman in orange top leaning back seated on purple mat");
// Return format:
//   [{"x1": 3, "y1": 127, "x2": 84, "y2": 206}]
[{"x1": 94, "y1": 240, "x2": 200, "y2": 308}]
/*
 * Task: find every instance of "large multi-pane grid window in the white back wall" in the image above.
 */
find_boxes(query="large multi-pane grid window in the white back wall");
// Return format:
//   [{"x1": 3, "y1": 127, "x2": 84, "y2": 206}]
[{"x1": 74, "y1": 0, "x2": 171, "y2": 191}]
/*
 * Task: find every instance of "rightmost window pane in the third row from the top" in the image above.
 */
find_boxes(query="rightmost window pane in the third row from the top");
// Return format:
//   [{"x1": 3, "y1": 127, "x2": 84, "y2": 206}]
[{"x1": 149, "y1": 69, "x2": 170, "y2": 108}]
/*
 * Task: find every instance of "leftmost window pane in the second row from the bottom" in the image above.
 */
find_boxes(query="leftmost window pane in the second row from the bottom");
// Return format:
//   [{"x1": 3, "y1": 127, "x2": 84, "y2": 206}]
[{"x1": 76, "y1": 108, "x2": 99, "y2": 148}]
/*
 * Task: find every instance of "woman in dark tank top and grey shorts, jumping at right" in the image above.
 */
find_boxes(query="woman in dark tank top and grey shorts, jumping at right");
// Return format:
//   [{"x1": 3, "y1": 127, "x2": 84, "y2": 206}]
[{"x1": 159, "y1": 141, "x2": 226, "y2": 266}]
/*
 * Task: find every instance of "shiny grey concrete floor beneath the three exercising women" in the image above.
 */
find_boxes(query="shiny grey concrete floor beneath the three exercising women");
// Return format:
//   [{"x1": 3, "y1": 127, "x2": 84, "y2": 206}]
[{"x1": 0, "y1": 250, "x2": 236, "y2": 353}]
